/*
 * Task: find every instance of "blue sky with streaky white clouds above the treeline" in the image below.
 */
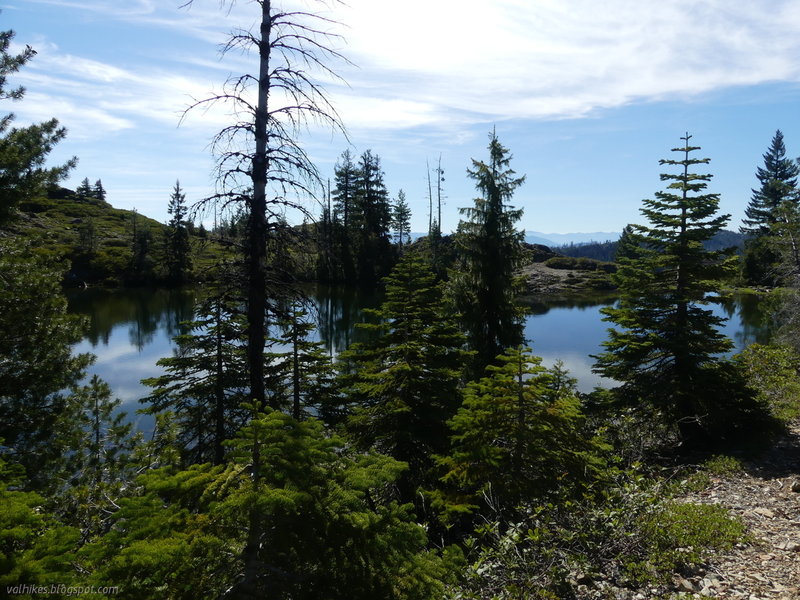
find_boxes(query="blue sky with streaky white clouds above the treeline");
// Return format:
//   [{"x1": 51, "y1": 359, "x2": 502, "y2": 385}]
[{"x1": 0, "y1": 0, "x2": 800, "y2": 233}]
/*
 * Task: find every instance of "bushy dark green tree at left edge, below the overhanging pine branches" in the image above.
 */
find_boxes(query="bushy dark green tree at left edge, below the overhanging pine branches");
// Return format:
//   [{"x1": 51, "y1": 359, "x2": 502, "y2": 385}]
[{"x1": 0, "y1": 240, "x2": 91, "y2": 487}]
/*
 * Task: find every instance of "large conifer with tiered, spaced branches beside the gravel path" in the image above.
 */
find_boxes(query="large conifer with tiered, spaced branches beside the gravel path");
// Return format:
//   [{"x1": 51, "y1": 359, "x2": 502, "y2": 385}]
[{"x1": 594, "y1": 134, "x2": 764, "y2": 443}]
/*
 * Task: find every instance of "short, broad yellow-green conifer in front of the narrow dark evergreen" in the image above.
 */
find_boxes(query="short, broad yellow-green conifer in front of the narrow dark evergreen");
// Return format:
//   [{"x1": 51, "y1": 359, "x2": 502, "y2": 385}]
[{"x1": 438, "y1": 348, "x2": 607, "y2": 518}]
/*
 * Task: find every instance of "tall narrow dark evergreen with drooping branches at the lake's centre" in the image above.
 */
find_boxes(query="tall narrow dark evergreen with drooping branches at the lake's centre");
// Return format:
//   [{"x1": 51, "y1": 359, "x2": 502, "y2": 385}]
[{"x1": 451, "y1": 131, "x2": 525, "y2": 374}]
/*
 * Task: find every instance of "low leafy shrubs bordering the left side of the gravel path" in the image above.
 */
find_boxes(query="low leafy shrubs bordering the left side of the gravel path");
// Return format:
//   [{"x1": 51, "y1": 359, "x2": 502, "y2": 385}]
[{"x1": 447, "y1": 471, "x2": 744, "y2": 600}]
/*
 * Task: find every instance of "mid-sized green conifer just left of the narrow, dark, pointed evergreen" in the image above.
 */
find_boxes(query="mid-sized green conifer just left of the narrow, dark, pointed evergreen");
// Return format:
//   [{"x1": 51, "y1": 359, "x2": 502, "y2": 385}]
[{"x1": 343, "y1": 252, "x2": 467, "y2": 502}]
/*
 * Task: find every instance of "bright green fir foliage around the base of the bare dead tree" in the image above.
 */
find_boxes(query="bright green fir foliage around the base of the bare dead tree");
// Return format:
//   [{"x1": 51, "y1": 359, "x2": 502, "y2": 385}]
[{"x1": 83, "y1": 412, "x2": 456, "y2": 600}]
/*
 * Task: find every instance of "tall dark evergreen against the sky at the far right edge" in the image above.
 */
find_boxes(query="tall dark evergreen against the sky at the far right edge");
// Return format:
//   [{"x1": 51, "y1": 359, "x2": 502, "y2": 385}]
[{"x1": 740, "y1": 130, "x2": 800, "y2": 285}]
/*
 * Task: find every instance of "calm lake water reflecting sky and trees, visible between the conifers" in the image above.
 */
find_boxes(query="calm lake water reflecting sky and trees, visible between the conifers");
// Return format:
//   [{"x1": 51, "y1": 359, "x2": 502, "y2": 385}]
[{"x1": 68, "y1": 287, "x2": 769, "y2": 428}]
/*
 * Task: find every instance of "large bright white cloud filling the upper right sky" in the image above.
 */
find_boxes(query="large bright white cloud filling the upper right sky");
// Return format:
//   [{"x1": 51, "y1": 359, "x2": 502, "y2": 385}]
[{"x1": 322, "y1": 0, "x2": 800, "y2": 125}]
